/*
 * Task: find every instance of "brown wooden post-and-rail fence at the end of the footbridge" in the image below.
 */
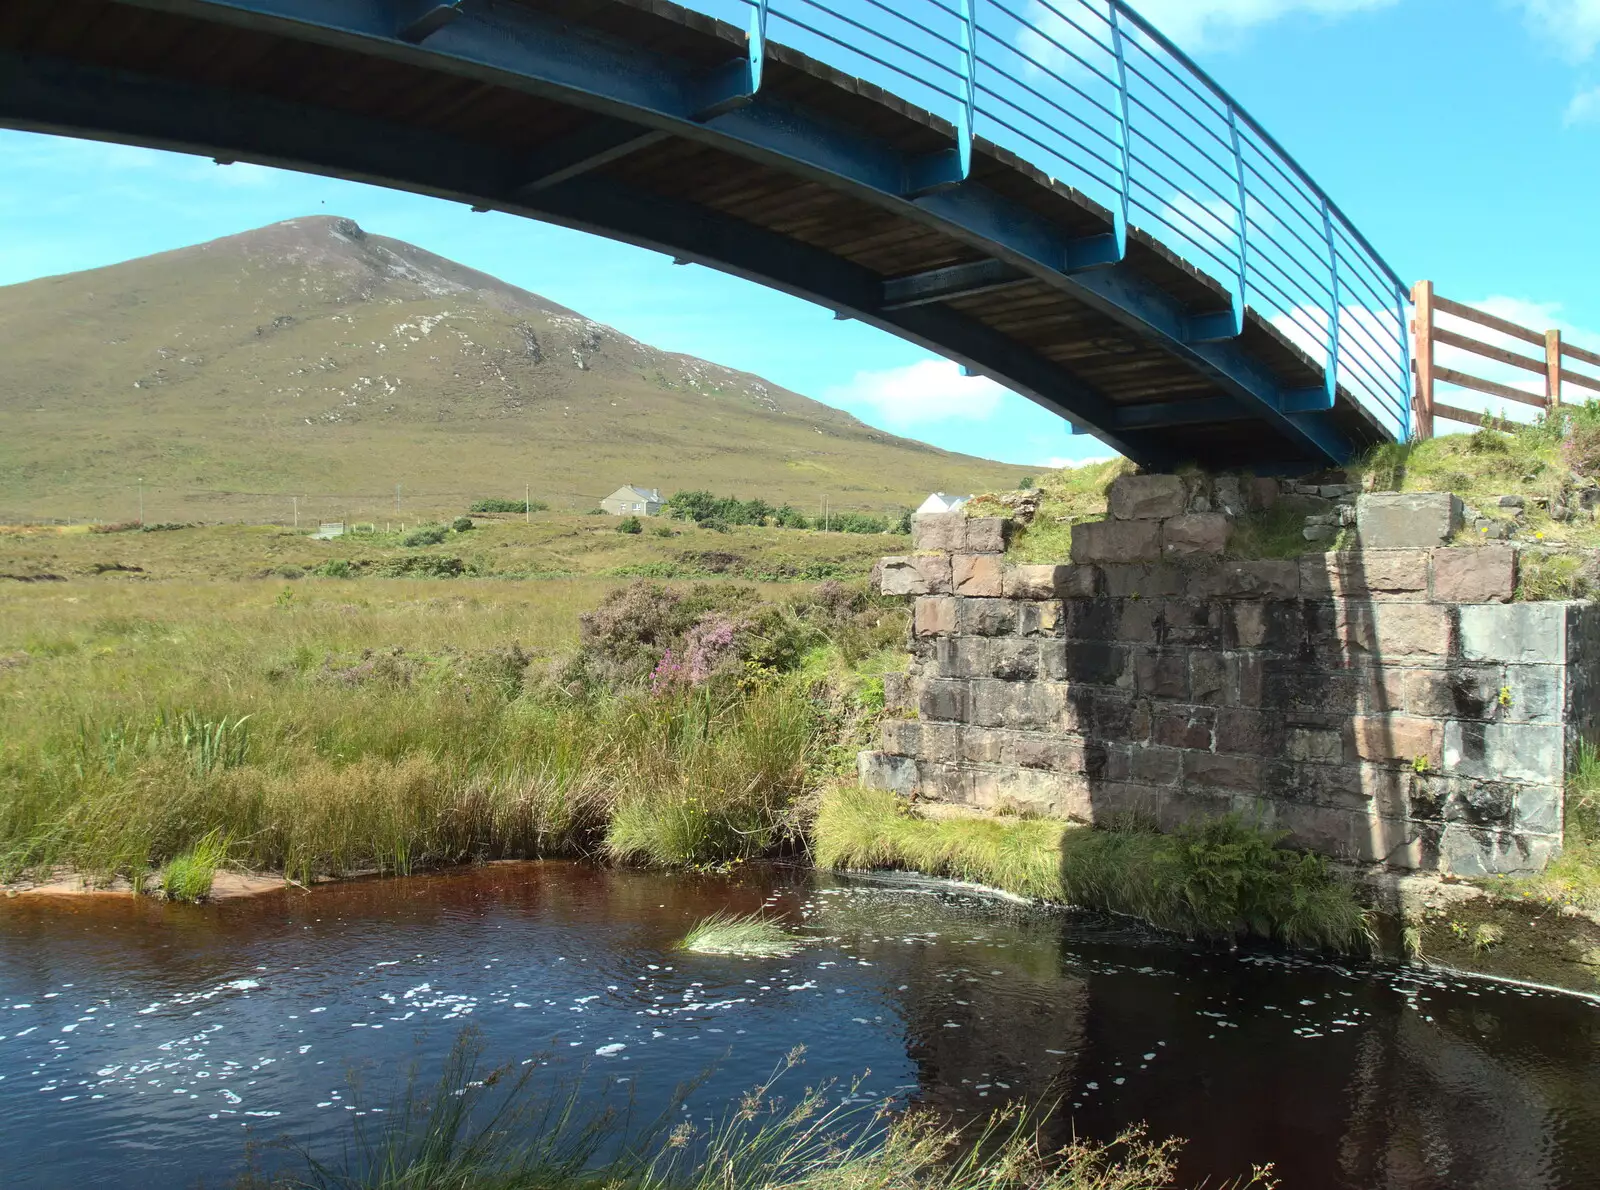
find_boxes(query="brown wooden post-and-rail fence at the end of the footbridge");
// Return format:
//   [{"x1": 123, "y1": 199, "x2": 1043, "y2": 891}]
[{"x1": 1411, "y1": 282, "x2": 1600, "y2": 438}]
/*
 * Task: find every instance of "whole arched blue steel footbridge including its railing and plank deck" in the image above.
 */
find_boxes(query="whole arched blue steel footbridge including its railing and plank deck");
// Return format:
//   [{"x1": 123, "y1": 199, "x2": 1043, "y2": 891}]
[{"x1": 0, "y1": 0, "x2": 1411, "y2": 472}]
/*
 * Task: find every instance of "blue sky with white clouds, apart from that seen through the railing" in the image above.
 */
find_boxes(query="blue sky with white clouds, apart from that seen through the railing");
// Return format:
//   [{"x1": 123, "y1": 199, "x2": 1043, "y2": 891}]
[{"x1": 0, "y1": 0, "x2": 1600, "y2": 464}]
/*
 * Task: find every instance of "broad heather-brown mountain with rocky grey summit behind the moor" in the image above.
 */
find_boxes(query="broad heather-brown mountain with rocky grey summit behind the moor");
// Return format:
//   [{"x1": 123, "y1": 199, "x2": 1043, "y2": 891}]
[{"x1": 0, "y1": 216, "x2": 1024, "y2": 520}]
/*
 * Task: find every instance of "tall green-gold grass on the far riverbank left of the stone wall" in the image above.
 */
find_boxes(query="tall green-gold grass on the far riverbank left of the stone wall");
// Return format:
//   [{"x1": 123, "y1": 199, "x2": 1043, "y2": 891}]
[{"x1": 0, "y1": 581, "x2": 901, "y2": 896}]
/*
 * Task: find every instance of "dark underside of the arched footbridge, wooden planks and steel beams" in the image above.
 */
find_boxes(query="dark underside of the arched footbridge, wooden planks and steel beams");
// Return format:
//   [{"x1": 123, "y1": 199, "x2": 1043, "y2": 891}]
[{"x1": 0, "y1": 0, "x2": 1387, "y2": 472}]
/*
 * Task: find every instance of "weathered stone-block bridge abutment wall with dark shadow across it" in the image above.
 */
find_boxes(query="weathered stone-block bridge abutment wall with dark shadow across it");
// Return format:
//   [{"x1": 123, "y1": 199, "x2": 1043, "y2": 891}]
[{"x1": 859, "y1": 492, "x2": 1600, "y2": 875}]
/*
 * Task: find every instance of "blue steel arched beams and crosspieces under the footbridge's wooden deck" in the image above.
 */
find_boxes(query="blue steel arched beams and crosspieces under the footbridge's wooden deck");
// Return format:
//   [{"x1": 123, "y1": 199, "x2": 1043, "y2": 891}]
[{"x1": 0, "y1": 0, "x2": 1414, "y2": 470}]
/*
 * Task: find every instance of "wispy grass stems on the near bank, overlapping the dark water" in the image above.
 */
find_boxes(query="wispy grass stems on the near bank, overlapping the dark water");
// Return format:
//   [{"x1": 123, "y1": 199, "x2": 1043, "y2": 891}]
[{"x1": 246, "y1": 1038, "x2": 1277, "y2": 1190}]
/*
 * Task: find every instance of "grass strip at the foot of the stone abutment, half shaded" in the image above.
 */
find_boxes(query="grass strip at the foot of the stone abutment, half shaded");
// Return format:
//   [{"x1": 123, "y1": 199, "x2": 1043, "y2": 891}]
[{"x1": 813, "y1": 789, "x2": 1370, "y2": 950}]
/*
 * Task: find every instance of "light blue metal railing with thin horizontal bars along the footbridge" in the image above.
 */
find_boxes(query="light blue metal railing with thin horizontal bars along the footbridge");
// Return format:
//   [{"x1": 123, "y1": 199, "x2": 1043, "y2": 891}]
[{"x1": 688, "y1": 0, "x2": 1411, "y2": 440}]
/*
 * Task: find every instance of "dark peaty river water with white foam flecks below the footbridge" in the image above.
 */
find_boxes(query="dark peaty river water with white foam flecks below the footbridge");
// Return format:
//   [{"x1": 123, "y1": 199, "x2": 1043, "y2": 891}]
[{"x1": 0, "y1": 862, "x2": 1600, "y2": 1190}]
